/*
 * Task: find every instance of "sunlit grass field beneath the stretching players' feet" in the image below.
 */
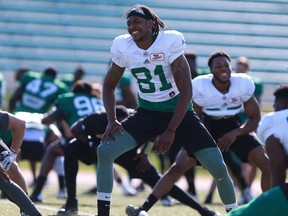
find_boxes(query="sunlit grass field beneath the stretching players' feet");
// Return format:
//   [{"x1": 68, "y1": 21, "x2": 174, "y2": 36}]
[{"x1": 0, "y1": 177, "x2": 230, "y2": 216}]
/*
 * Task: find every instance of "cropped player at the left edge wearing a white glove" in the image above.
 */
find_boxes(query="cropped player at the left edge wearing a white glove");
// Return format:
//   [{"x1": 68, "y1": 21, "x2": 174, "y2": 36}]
[{"x1": 0, "y1": 111, "x2": 41, "y2": 216}]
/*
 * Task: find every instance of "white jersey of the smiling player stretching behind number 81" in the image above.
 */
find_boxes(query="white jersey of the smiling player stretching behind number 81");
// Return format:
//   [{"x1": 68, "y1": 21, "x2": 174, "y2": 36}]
[{"x1": 192, "y1": 73, "x2": 255, "y2": 117}]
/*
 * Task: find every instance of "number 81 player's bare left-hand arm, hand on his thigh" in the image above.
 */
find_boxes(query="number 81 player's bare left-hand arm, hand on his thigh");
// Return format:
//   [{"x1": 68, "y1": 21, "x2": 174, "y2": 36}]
[{"x1": 103, "y1": 62, "x2": 125, "y2": 143}]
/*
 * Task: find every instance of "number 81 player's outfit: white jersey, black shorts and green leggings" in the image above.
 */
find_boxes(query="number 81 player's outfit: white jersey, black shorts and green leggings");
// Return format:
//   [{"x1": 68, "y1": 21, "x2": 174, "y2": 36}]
[{"x1": 97, "y1": 31, "x2": 235, "y2": 210}]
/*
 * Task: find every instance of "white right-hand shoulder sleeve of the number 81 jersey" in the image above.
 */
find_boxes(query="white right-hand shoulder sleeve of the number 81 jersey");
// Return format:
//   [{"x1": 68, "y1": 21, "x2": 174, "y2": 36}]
[{"x1": 168, "y1": 31, "x2": 186, "y2": 64}]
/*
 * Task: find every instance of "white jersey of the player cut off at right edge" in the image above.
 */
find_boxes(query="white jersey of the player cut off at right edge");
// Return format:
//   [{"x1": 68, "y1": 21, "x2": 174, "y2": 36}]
[{"x1": 257, "y1": 109, "x2": 288, "y2": 155}]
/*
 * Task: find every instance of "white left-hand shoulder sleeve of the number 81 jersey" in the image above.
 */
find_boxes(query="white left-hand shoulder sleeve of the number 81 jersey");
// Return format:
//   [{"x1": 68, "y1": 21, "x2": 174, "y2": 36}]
[{"x1": 110, "y1": 35, "x2": 127, "y2": 68}]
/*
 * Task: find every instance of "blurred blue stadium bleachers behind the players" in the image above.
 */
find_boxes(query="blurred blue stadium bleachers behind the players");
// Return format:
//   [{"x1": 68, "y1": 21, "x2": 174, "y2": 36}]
[{"x1": 0, "y1": 0, "x2": 288, "y2": 108}]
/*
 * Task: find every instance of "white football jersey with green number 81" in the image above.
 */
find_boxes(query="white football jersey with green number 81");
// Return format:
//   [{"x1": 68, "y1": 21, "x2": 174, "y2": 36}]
[{"x1": 111, "y1": 30, "x2": 186, "y2": 102}]
